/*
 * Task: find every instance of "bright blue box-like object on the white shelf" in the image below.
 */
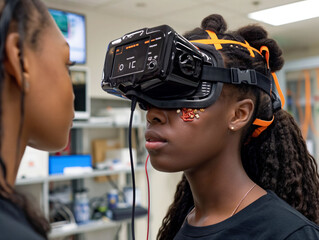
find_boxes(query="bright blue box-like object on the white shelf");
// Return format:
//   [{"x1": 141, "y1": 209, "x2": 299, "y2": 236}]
[{"x1": 49, "y1": 155, "x2": 92, "y2": 175}]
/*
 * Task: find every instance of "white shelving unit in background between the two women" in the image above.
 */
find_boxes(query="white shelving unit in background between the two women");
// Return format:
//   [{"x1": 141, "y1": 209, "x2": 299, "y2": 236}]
[{"x1": 16, "y1": 117, "x2": 148, "y2": 239}]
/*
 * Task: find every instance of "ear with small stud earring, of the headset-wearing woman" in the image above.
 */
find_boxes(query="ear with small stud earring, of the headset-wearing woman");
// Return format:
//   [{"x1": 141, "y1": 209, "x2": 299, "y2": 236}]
[{"x1": 229, "y1": 99, "x2": 254, "y2": 131}]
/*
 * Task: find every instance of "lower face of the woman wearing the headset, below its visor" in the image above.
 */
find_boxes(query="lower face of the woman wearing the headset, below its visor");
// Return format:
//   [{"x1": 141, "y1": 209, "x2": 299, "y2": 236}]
[{"x1": 145, "y1": 89, "x2": 233, "y2": 172}]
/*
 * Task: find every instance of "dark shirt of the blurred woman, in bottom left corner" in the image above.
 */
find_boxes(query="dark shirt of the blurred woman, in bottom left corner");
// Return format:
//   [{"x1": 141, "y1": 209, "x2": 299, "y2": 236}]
[{"x1": 0, "y1": 197, "x2": 44, "y2": 240}]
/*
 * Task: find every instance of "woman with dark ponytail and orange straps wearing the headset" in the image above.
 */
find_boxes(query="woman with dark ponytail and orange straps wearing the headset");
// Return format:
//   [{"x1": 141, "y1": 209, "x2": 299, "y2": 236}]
[{"x1": 146, "y1": 15, "x2": 319, "y2": 240}]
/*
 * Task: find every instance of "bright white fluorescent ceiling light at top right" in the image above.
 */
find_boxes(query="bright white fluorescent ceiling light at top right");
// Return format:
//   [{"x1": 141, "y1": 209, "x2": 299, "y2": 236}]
[{"x1": 248, "y1": 0, "x2": 319, "y2": 26}]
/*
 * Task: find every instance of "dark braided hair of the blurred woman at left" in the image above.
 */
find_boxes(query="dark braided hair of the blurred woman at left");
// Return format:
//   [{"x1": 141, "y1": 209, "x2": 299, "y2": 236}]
[{"x1": 0, "y1": 0, "x2": 50, "y2": 236}]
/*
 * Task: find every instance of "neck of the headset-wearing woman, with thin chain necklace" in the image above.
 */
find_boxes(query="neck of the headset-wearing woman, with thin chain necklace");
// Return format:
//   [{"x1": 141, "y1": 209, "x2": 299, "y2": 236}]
[{"x1": 185, "y1": 149, "x2": 266, "y2": 226}]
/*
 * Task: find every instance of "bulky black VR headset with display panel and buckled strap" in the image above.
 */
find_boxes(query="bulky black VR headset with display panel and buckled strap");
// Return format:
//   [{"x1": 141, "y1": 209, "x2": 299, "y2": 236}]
[{"x1": 101, "y1": 25, "x2": 281, "y2": 110}]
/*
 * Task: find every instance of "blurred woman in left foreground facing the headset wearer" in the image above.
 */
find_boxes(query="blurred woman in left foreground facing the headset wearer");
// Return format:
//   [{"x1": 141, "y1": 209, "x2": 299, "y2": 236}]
[{"x1": 0, "y1": 0, "x2": 74, "y2": 240}]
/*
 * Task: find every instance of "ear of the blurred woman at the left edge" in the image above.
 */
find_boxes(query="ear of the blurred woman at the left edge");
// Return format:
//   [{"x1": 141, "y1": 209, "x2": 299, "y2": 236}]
[{"x1": 4, "y1": 32, "x2": 29, "y2": 92}]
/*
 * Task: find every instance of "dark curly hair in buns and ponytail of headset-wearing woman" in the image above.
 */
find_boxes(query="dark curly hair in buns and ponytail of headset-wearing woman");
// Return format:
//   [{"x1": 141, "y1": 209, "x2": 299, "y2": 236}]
[{"x1": 157, "y1": 14, "x2": 319, "y2": 240}]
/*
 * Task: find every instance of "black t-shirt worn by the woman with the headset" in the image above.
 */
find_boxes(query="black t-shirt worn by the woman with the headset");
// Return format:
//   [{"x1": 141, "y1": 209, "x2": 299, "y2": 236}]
[{"x1": 174, "y1": 191, "x2": 319, "y2": 240}]
